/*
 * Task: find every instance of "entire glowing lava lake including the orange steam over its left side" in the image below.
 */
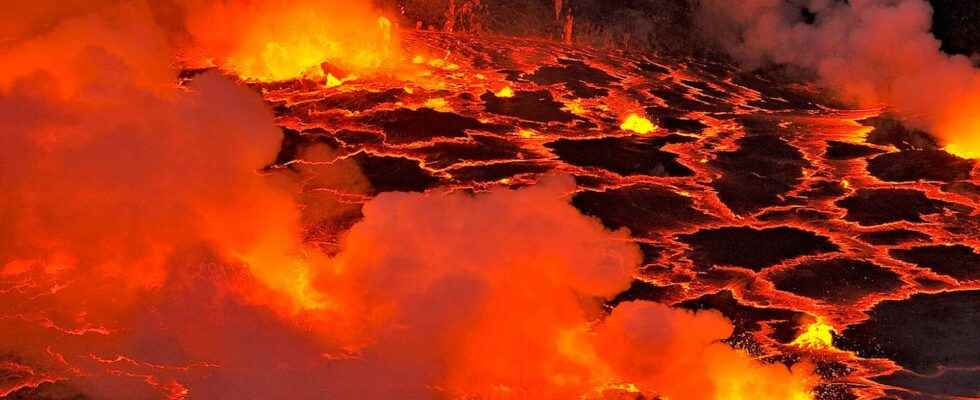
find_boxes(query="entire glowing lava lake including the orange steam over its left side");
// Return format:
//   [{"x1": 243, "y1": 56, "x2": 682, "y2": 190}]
[{"x1": 0, "y1": 0, "x2": 980, "y2": 400}]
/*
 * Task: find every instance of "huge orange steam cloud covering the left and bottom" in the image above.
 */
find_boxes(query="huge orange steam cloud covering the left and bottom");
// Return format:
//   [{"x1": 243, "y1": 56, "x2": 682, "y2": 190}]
[{"x1": 0, "y1": 2, "x2": 810, "y2": 400}]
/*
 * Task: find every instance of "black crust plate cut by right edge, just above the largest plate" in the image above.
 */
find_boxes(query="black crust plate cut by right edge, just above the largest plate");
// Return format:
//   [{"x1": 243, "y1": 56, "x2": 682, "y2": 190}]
[{"x1": 889, "y1": 244, "x2": 980, "y2": 282}]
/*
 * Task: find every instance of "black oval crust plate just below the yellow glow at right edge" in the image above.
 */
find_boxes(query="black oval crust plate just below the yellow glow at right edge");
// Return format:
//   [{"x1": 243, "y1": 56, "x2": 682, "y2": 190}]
[{"x1": 868, "y1": 150, "x2": 973, "y2": 182}]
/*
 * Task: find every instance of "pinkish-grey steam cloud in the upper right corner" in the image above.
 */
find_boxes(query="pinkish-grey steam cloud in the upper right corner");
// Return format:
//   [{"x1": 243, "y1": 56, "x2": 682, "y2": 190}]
[{"x1": 701, "y1": 0, "x2": 980, "y2": 157}]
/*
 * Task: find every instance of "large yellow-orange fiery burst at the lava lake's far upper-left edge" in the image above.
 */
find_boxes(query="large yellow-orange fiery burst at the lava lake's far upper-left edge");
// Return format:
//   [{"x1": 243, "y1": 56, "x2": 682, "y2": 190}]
[{"x1": 189, "y1": 0, "x2": 397, "y2": 85}]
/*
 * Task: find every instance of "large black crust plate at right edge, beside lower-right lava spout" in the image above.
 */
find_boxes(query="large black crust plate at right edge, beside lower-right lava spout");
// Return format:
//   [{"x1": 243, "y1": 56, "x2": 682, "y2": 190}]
[{"x1": 834, "y1": 290, "x2": 980, "y2": 374}]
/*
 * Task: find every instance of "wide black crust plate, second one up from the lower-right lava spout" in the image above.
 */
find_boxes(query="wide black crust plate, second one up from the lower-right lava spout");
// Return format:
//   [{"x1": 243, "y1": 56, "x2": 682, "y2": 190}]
[{"x1": 678, "y1": 226, "x2": 838, "y2": 271}]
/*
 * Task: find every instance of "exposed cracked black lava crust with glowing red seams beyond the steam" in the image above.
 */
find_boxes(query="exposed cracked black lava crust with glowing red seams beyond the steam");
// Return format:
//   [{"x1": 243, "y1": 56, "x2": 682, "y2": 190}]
[{"x1": 7, "y1": 33, "x2": 980, "y2": 399}]
